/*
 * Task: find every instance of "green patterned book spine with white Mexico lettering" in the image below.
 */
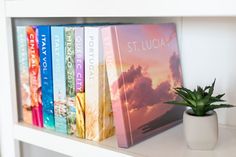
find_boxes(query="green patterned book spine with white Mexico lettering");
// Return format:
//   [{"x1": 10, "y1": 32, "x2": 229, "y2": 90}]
[{"x1": 65, "y1": 27, "x2": 76, "y2": 135}]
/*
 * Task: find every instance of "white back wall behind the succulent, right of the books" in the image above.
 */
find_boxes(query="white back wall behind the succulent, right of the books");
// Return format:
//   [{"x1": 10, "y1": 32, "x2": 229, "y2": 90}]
[{"x1": 181, "y1": 17, "x2": 236, "y2": 126}]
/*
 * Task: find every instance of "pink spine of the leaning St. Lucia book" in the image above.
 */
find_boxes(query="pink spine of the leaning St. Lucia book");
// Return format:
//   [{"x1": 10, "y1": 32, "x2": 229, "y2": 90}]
[{"x1": 101, "y1": 27, "x2": 132, "y2": 148}]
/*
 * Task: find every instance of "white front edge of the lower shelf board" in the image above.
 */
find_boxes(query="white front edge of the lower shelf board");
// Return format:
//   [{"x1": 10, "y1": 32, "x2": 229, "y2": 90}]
[{"x1": 14, "y1": 123, "x2": 132, "y2": 157}]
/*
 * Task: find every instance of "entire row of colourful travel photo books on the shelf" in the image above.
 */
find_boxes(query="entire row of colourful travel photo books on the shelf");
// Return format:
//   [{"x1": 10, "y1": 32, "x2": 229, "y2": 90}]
[{"x1": 17, "y1": 23, "x2": 184, "y2": 147}]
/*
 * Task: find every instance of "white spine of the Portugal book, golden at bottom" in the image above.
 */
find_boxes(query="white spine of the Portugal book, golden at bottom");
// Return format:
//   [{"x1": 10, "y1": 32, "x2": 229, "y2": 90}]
[{"x1": 84, "y1": 27, "x2": 102, "y2": 141}]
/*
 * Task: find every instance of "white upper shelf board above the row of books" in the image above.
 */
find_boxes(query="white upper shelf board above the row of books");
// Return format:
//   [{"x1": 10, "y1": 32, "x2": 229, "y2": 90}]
[{"x1": 5, "y1": 0, "x2": 236, "y2": 17}]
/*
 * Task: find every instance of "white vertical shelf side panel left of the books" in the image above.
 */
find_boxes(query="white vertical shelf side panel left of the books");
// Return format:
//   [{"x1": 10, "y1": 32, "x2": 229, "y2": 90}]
[{"x1": 0, "y1": 0, "x2": 20, "y2": 157}]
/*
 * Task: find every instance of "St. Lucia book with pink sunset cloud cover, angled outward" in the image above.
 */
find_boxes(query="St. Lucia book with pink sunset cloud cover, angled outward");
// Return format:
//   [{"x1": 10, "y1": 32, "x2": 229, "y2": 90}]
[{"x1": 101, "y1": 24, "x2": 185, "y2": 148}]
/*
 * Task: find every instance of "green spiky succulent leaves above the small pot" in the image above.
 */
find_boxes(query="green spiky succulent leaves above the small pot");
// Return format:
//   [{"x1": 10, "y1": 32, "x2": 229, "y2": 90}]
[{"x1": 166, "y1": 80, "x2": 234, "y2": 116}]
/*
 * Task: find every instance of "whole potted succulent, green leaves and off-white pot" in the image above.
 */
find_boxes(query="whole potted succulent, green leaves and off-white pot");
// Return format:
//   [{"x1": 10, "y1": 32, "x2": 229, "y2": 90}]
[{"x1": 166, "y1": 80, "x2": 233, "y2": 150}]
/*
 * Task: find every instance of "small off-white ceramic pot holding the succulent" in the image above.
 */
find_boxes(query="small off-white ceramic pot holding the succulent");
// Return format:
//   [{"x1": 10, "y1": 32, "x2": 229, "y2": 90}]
[{"x1": 183, "y1": 109, "x2": 218, "y2": 150}]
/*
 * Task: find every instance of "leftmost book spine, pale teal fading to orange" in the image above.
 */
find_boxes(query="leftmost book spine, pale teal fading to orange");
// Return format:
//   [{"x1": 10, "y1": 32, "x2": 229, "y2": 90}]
[{"x1": 16, "y1": 26, "x2": 32, "y2": 124}]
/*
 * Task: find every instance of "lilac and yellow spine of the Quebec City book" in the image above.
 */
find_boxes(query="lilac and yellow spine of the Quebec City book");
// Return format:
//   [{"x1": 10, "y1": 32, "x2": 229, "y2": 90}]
[{"x1": 75, "y1": 27, "x2": 85, "y2": 138}]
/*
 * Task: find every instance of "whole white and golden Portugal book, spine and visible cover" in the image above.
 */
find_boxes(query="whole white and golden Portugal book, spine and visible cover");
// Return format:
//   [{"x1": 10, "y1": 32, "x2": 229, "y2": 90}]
[{"x1": 85, "y1": 27, "x2": 114, "y2": 141}]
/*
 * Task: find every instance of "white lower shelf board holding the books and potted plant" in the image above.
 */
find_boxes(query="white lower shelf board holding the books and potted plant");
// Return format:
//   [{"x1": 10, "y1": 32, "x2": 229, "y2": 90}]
[{"x1": 14, "y1": 123, "x2": 236, "y2": 157}]
